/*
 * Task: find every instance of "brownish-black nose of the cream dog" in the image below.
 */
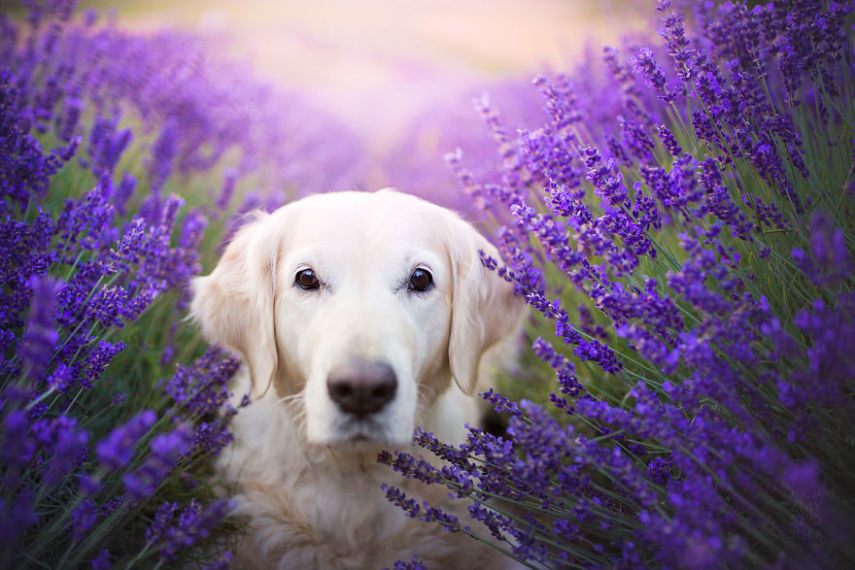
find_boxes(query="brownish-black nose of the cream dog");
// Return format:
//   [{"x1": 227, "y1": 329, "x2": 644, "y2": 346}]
[{"x1": 327, "y1": 360, "x2": 398, "y2": 417}]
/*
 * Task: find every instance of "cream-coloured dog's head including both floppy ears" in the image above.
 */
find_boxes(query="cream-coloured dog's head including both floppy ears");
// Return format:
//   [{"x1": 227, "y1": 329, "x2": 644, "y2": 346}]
[{"x1": 191, "y1": 190, "x2": 522, "y2": 445}]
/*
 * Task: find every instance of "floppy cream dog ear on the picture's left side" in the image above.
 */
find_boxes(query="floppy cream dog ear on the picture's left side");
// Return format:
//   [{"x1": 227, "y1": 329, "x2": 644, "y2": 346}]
[{"x1": 190, "y1": 212, "x2": 281, "y2": 397}]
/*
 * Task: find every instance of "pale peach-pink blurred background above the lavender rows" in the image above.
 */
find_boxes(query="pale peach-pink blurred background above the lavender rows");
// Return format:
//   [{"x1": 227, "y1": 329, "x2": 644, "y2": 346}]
[{"x1": 18, "y1": 0, "x2": 653, "y2": 160}]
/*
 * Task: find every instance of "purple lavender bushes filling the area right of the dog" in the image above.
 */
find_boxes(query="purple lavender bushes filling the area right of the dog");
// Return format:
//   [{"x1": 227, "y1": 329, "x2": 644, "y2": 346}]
[{"x1": 379, "y1": 1, "x2": 855, "y2": 568}]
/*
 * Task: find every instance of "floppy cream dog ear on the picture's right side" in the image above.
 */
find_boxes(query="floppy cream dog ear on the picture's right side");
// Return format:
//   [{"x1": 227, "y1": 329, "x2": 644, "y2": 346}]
[{"x1": 448, "y1": 218, "x2": 525, "y2": 395}]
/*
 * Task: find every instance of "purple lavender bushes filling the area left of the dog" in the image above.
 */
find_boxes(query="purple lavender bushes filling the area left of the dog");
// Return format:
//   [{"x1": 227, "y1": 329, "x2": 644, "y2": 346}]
[{"x1": 0, "y1": 0, "x2": 360, "y2": 568}]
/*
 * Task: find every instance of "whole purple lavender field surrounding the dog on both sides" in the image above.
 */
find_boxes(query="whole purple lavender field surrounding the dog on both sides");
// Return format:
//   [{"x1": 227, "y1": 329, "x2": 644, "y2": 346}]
[{"x1": 0, "y1": 0, "x2": 855, "y2": 569}]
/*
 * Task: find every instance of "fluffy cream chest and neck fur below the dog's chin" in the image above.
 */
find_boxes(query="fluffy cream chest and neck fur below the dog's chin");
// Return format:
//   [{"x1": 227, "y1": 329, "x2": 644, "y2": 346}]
[{"x1": 217, "y1": 392, "x2": 444, "y2": 567}]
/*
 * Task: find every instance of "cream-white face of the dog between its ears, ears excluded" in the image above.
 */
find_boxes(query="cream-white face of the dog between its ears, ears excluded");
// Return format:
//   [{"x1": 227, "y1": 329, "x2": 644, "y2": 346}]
[{"x1": 276, "y1": 196, "x2": 462, "y2": 443}]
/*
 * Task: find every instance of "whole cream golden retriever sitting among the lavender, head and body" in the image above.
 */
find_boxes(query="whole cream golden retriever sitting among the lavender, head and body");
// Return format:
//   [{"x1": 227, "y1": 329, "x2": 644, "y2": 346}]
[{"x1": 191, "y1": 189, "x2": 524, "y2": 569}]
